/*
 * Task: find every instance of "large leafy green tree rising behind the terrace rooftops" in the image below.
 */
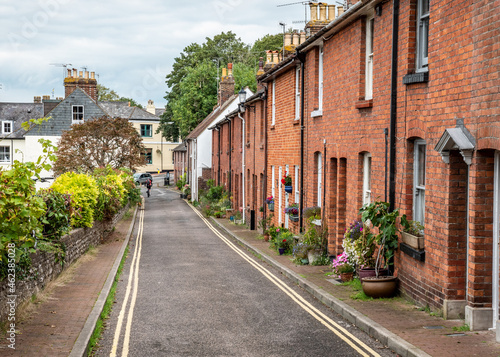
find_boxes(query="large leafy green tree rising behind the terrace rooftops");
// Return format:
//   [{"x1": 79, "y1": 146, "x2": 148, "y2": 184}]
[{"x1": 157, "y1": 31, "x2": 283, "y2": 141}]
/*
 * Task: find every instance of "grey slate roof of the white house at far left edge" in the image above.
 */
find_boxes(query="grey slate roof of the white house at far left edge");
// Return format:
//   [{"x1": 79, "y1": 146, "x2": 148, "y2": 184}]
[{"x1": 0, "y1": 103, "x2": 43, "y2": 139}]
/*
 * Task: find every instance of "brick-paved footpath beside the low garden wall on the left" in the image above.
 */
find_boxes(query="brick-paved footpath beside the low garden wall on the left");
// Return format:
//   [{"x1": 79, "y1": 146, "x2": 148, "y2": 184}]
[{"x1": 0, "y1": 213, "x2": 132, "y2": 357}]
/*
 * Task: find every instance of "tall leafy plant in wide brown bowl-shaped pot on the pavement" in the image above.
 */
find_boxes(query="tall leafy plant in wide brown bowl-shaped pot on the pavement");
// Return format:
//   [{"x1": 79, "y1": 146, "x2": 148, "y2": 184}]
[{"x1": 359, "y1": 201, "x2": 399, "y2": 298}]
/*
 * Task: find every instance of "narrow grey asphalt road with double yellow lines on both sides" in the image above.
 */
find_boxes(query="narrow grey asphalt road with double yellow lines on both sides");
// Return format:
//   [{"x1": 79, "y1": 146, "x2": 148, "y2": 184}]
[{"x1": 96, "y1": 188, "x2": 394, "y2": 357}]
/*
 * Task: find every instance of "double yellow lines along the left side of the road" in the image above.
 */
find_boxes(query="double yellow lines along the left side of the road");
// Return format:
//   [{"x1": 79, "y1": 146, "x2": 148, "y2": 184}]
[{"x1": 109, "y1": 210, "x2": 144, "y2": 357}]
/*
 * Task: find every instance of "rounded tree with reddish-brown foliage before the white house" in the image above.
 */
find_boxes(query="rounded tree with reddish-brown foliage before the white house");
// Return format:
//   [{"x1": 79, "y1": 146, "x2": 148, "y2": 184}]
[{"x1": 53, "y1": 116, "x2": 145, "y2": 175}]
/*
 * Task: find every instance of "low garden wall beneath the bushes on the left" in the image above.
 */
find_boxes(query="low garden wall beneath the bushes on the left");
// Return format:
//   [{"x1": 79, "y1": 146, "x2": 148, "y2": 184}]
[{"x1": 0, "y1": 205, "x2": 129, "y2": 322}]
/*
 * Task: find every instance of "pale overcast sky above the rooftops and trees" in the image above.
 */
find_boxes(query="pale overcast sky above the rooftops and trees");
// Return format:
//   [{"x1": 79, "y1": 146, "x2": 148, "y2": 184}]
[{"x1": 0, "y1": 0, "x2": 305, "y2": 107}]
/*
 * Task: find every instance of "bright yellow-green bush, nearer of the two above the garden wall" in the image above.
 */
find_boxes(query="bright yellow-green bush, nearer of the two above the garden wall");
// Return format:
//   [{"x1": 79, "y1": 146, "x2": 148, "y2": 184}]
[{"x1": 52, "y1": 172, "x2": 99, "y2": 228}]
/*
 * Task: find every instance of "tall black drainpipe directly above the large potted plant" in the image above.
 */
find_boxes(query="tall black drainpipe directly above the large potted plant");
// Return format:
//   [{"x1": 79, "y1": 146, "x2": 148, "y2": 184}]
[{"x1": 389, "y1": 0, "x2": 399, "y2": 212}]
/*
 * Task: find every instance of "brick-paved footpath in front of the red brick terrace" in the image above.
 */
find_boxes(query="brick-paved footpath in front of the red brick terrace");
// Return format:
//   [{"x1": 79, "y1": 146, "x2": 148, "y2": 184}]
[{"x1": 216, "y1": 219, "x2": 500, "y2": 357}]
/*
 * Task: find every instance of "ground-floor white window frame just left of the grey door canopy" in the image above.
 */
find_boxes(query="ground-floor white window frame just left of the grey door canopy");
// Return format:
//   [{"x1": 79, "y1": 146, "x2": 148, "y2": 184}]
[{"x1": 413, "y1": 139, "x2": 427, "y2": 225}]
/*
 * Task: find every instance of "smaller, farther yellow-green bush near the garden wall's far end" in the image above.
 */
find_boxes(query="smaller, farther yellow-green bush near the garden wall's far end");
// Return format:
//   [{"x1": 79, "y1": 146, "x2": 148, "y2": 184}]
[{"x1": 93, "y1": 166, "x2": 127, "y2": 221}]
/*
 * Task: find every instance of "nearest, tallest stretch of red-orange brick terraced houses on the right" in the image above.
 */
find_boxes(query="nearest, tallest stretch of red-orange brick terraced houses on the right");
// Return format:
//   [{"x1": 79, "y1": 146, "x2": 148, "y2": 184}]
[{"x1": 254, "y1": 0, "x2": 500, "y2": 330}]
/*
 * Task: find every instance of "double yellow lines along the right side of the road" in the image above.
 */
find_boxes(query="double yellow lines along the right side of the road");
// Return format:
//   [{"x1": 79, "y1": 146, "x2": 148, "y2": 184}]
[{"x1": 191, "y1": 206, "x2": 380, "y2": 357}]
